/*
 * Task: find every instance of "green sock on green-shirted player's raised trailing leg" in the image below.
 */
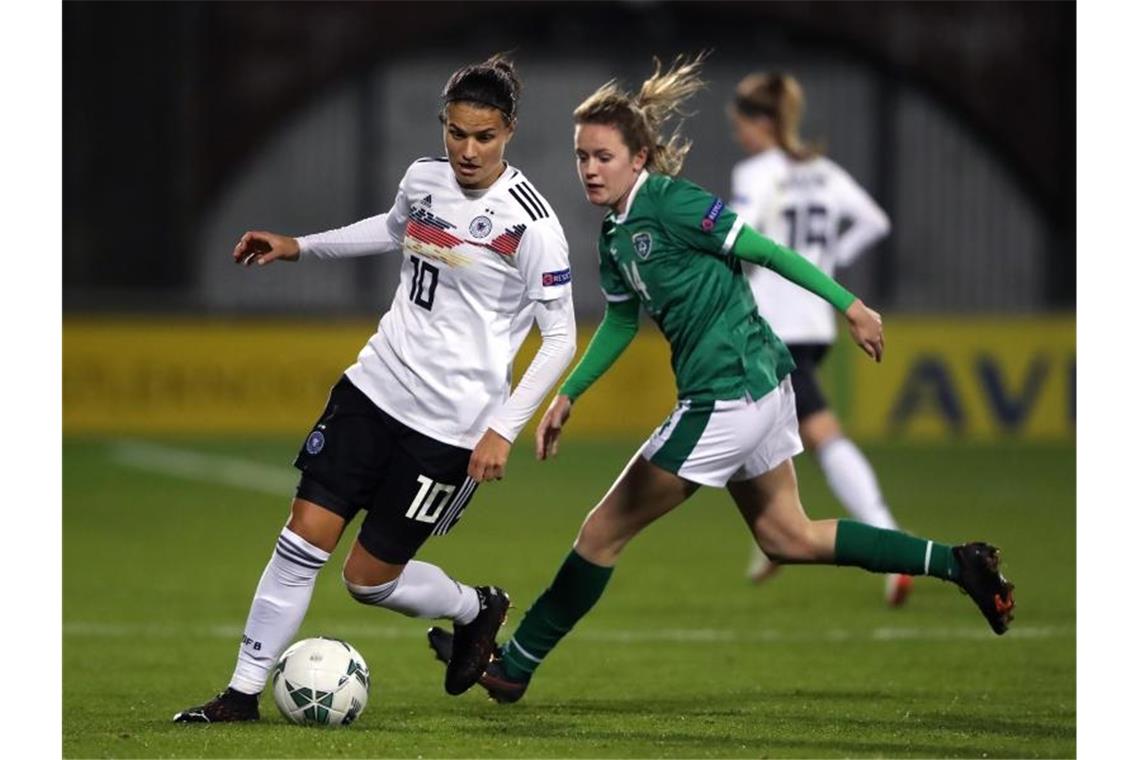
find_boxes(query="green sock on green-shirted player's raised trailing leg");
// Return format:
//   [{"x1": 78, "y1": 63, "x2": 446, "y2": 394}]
[{"x1": 836, "y1": 520, "x2": 958, "y2": 581}]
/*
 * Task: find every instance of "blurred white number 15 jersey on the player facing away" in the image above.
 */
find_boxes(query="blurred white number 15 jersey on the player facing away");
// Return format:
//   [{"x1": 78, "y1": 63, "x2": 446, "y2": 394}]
[{"x1": 732, "y1": 148, "x2": 890, "y2": 344}]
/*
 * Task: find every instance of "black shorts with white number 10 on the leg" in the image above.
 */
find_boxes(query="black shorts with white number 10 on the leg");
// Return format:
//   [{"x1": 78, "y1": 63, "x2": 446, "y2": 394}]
[{"x1": 293, "y1": 377, "x2": 477, "y2": 565}]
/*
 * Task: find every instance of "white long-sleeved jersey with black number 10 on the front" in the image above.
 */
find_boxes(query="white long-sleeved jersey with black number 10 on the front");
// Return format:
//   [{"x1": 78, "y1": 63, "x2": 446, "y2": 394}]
[{"x1": 299, "y1": 158, "x2": 573, "y2": 449}]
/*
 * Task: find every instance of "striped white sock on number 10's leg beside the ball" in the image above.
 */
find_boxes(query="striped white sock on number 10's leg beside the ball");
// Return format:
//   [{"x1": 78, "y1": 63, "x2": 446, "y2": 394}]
[{"x1": 229, "y1": 528, "x2": 328, "y2": 694}]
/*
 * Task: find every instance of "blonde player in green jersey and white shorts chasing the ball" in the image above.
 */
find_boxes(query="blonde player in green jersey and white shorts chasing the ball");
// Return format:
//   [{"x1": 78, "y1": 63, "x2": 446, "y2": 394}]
[{"x1": 429, "y1": 59, "x2": 1013, "y2": 702}]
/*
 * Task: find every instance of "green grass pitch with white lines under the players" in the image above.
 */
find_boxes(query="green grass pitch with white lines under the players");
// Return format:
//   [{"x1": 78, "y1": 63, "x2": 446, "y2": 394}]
[{"x1": 63, "y1": 435, "x2": 1076, "y2": 758}]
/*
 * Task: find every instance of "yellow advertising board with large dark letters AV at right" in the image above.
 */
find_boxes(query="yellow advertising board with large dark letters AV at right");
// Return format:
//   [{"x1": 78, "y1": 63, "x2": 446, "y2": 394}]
[{"x1": 840, "y1": 316, "x2": 1076, "y2": 440}]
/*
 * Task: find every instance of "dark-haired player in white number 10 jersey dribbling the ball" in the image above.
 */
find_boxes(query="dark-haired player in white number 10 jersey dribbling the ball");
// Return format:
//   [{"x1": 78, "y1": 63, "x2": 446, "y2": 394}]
[{"x1": 174, "y1": 56, "x2": 575, "y2": 722}]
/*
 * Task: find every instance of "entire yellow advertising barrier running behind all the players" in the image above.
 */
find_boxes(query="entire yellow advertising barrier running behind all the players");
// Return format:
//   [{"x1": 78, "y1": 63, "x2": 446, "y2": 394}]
[{"x1": 63, "y1": 316, "x2": 1076, "y2": 441}]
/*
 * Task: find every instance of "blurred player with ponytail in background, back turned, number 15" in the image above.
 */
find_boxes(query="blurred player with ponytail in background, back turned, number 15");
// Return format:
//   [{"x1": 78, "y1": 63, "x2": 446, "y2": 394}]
[{"x1": 730, "y1": 74, "x2": 911, "y2": 606}]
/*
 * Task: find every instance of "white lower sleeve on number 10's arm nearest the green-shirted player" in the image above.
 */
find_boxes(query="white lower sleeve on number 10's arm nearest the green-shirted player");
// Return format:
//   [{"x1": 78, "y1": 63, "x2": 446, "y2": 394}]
[{"x1": 488, "y1": 293, "x2": 578, "y2": 443}]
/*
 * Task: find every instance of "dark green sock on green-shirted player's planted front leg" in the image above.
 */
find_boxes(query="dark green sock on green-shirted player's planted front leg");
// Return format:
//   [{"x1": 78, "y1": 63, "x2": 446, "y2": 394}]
[{"x1": 503, "y1": 549, "x2": 613, "y2": 680}]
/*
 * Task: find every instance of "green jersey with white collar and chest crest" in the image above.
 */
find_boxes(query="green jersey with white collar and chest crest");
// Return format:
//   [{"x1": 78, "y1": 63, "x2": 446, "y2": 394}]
[{"x1": 599, "y1": 172, "x2": 796, "y2": 401}]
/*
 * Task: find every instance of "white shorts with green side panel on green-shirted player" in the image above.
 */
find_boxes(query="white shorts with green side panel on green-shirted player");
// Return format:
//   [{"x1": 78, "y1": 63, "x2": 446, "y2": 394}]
[{"x1": 641, "y1": 377, "x2": 804, "y2": 488}]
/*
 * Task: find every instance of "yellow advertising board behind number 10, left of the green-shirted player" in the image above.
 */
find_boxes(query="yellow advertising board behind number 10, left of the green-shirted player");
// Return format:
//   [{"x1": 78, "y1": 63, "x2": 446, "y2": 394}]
[{"x1": 63, "y1": 318, "x2": 675, "y2": 435}]
